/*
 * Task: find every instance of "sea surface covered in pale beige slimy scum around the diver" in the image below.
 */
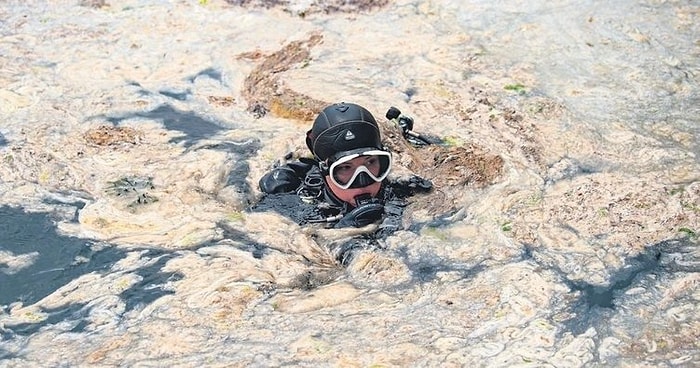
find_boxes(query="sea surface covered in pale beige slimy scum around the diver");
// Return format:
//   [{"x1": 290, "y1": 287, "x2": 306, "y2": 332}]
[{"x1": 0, "y1": 0, "x2": 700, "y2": 367}]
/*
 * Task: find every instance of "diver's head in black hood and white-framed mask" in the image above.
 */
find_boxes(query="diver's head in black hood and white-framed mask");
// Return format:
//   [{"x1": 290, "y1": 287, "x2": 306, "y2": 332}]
[{"x1": 306, "y1": 103, "x2": 391, "y2": 206}]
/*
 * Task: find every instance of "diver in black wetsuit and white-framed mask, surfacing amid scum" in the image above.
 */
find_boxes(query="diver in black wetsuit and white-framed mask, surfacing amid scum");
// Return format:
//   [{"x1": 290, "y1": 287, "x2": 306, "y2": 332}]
[{"x1": 253, "y1": 102, "x2": 432, "y2": 238}]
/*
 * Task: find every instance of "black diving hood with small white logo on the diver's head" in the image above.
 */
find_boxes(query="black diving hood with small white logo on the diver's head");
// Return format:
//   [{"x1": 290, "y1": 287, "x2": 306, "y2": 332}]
[{"x1": 306, "y1": 102, "x2": 382, "y2": 161}]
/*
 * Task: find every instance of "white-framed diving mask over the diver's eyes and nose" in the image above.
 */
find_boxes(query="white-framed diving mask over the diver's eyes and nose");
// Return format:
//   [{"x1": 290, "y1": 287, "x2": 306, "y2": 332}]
[{"x1": 329, "y1": 150, "x2": 391, "y2": 189}]
